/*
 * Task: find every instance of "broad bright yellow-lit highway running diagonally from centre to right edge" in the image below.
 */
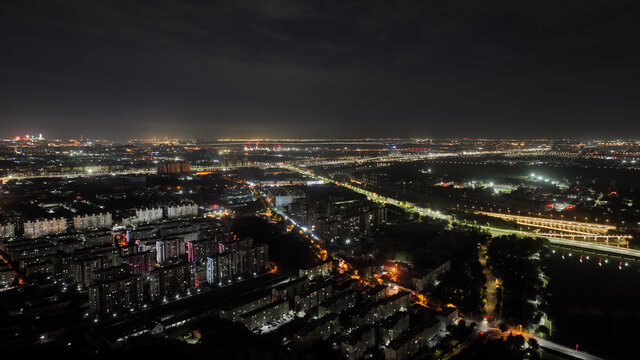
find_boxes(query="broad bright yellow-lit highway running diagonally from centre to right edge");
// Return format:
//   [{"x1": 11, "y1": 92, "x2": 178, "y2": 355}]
[{"x1": 286, "y1": 165, "x2": 640, "y2": 258}]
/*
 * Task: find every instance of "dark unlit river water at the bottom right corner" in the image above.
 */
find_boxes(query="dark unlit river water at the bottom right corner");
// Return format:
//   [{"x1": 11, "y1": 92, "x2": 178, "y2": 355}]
[{"x1": 549, "y1": 250, "x2": 640, "y2": 360}]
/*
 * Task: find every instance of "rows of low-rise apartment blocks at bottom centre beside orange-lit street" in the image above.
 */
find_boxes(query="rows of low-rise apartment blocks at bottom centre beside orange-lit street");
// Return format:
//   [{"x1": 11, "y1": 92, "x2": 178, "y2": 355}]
[{"x1": 212, "y1": 261, "x2": 458, "y2": 360}]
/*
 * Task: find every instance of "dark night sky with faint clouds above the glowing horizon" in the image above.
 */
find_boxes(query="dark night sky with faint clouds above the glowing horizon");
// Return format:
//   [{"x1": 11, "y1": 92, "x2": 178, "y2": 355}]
[{"x1": 0, "y1": 0, "x2": 640, "y2": 139}]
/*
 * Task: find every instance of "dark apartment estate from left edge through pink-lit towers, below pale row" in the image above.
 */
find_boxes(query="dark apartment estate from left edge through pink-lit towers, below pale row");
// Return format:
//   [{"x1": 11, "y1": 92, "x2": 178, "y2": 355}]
[{"x1": 0, "y1": 217, "x2": 268, "y2": 316}]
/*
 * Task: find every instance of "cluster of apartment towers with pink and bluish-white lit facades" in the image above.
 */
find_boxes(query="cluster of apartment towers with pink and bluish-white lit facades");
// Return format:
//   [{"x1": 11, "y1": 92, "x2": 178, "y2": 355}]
[{"x1": 90, "y1": 226, "x2": 268, "y2": 314}]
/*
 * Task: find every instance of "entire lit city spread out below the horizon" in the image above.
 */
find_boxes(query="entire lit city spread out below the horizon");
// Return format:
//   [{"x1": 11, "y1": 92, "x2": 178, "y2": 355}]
[{"x1": 0, "y1": 133, "x2": 640, "y2": 360}]
